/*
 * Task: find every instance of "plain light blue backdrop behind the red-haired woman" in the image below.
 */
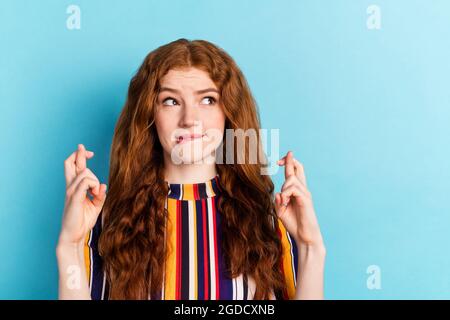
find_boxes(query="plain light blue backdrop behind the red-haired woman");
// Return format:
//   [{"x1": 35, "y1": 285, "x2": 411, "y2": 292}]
[{"x1": 0, "y1": 0, "x2": 450, "y2": 299}]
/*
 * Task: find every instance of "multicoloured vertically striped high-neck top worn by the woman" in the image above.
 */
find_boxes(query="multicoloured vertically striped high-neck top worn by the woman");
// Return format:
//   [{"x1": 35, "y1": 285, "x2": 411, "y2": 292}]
[{"x1": 84, "y1": 175, "x2": 298, "y2": 300}]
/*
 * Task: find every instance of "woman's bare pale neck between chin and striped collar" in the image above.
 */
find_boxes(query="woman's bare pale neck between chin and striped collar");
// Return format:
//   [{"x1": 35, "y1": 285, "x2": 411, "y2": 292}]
[{"x1": 164, "y1": 151, "x2": 217, "y2": 183}]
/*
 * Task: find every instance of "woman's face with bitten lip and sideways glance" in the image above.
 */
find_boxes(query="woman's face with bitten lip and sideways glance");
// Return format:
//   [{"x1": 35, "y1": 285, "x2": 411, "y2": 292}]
[{"x1": 155, "y1": 68, "x2": 225, "y2": 164}]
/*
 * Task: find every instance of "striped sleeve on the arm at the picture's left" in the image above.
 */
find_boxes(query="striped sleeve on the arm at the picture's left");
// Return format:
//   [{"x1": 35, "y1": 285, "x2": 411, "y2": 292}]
[{"x1": 84, "y1": 214, "x2": 108, "y2": 300}]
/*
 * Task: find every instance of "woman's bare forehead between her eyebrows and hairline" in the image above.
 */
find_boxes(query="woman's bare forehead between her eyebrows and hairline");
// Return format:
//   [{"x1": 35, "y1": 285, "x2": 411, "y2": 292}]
[{"x1": 160, "y1": 68, "x2": 217, "y2": 90}]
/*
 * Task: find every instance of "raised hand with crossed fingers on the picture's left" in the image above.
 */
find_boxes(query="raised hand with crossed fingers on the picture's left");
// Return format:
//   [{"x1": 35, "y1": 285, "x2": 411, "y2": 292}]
[{"x1": 59, "y1": 144, "x2": 106, "y2": 245}]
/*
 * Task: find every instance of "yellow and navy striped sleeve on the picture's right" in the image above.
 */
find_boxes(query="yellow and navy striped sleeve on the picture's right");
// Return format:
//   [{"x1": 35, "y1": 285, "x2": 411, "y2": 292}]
[{"x1": 276, "y1": 218, "x2": 298, "y2": 300}]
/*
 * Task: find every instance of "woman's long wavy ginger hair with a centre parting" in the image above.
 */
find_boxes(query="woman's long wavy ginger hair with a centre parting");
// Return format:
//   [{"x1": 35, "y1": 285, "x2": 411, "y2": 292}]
[{"x1": 99, "y1": 39, "x2": 286, "y2": 299}]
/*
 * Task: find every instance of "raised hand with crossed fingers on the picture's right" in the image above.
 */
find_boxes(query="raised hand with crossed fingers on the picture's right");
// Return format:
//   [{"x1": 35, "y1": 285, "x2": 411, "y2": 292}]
[{"x1": 275, "y1": 151, "x2": 325, "y2": 249}]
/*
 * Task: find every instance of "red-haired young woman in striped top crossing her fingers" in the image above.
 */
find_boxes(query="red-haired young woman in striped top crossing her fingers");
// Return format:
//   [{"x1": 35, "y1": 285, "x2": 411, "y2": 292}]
[{"x1": 56, "y1": 39, "x2": 325, "y2": 300}]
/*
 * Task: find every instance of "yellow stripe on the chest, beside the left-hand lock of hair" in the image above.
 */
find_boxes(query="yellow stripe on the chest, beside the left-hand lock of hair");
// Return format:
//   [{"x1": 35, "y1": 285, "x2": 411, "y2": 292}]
[{"x1": 164, "y1": 198, "x2": 177, "y2": 300}]
